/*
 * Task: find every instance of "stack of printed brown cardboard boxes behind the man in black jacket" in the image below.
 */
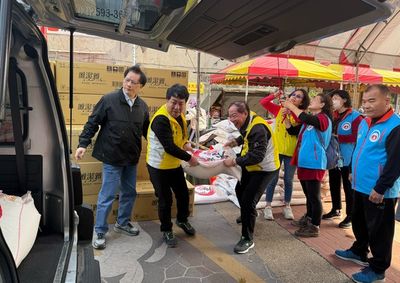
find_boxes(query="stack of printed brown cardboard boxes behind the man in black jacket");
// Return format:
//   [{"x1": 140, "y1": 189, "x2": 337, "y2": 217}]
[{"x1": 51, "y1": 62, "x2": 194, "y2": 223}]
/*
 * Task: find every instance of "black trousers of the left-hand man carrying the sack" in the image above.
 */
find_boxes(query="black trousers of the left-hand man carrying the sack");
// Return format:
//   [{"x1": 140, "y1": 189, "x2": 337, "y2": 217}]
[{"x1": 147, "y1": 165, "x2": 189, "y2": 232}]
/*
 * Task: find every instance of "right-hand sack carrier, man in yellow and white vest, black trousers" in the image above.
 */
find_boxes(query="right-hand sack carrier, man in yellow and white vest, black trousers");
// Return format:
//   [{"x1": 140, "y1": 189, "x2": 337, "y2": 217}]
[{"x1": 224, "y1": 102, "x2": 280, "y2": 254}]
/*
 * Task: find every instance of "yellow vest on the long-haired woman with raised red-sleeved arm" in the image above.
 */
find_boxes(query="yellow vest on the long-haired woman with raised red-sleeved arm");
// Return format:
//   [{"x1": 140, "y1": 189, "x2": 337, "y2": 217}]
[{"x1": 274, "y1": 109, "x2": 298, "y2": 156}]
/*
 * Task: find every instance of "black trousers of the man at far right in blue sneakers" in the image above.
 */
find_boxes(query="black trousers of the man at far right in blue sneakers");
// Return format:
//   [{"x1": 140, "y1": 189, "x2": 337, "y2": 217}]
[{"x1": 351, "y1": 191, "x2": 397, "y2": 273}]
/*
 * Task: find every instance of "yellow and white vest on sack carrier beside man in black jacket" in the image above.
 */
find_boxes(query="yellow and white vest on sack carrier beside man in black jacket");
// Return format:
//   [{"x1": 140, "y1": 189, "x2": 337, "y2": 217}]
[{"x1": 146, "y1": 104, "x2": 188, "y2": 169}]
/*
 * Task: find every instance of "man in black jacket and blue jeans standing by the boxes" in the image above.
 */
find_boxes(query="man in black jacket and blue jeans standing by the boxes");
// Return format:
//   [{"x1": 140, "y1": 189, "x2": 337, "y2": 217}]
[{"x1": 75, "y1": 66, "x2": 149, "y2": 249}]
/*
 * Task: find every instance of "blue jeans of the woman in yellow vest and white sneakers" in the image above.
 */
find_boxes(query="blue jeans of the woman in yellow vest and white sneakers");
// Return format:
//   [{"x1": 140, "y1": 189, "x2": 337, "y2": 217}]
[{"x1": 265, "y1": 154, "x2": 296, "y2": 203}]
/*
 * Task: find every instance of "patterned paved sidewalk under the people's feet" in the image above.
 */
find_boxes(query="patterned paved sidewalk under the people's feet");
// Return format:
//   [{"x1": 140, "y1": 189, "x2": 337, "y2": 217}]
[{"x1": 95, "y1": 202, "x2": 394, "y2": 283}]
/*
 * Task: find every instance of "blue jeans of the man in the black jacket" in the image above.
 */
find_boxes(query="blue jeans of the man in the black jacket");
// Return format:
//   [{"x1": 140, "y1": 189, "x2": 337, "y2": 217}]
[{"x1": 94, "y1": 163, "x2": 137, "y2": 233}]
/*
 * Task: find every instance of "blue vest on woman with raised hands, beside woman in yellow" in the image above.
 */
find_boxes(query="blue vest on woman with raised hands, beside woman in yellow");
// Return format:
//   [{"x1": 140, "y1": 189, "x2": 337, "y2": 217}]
[{"x1": 297, "y1": 118, "x2": 332, "y2": 170}]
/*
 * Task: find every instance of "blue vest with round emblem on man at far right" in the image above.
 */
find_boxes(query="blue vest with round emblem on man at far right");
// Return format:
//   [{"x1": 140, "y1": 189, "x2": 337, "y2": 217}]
[{"x1": 352, "y1": 111, "x2": 400, "y2": 198}]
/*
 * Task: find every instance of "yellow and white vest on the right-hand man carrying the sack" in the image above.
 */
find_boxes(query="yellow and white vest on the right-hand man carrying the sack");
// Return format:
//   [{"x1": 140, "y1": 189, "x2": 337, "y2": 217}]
[{"x1": 240, "y1": 112, "x2": 280, "y2": 172}]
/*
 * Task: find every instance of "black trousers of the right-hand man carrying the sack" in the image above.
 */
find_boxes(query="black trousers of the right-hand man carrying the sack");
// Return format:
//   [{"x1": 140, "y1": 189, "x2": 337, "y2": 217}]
[{"x1": 235, "y1": 169, "x2": 276, "y2": 240}]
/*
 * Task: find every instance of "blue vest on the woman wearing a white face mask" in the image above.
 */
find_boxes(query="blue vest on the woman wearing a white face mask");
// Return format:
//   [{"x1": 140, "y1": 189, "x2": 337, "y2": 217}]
[{"x1": 337, "y1": 110, "x2": 360, "y2": 166}]
